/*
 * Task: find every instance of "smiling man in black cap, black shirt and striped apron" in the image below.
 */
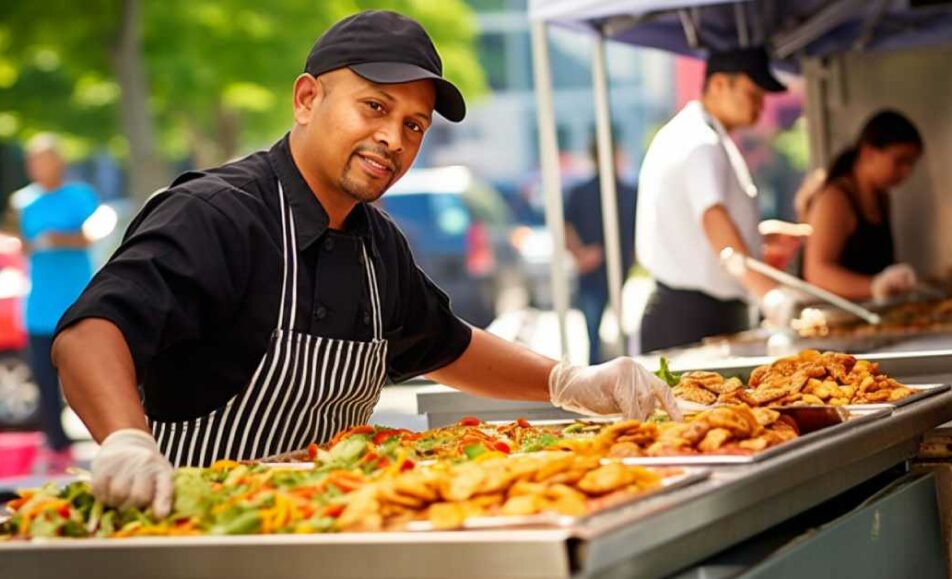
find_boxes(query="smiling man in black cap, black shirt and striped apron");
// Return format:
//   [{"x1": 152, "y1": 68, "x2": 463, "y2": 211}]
[{"x1": 53, "y1": 11, "x2": 677, "y2": 516}]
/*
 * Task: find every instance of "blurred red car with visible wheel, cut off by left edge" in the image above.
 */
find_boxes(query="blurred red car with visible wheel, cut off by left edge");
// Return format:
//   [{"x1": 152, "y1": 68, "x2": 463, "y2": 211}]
[{"x1": 0, "y1": 234, "x2": 40, "y2": 430}]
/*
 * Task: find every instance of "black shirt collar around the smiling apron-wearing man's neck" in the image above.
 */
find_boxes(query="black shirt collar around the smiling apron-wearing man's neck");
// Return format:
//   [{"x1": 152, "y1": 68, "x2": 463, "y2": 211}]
[{"x1": 268, "y1": 133, "x2": 372, "y2": 250}]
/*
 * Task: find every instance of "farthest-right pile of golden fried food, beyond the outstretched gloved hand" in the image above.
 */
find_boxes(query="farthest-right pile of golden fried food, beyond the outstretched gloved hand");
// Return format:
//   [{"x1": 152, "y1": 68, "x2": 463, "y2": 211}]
[{"x1": 674, "y1": 350, "x2": 914, "y2": 407}]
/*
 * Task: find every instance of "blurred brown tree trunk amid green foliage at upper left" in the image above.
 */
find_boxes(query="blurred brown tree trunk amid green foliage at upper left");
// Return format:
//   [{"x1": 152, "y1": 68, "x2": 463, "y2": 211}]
[{"x1": 114, "y1": 0, "x2": 169, "y2": 200}]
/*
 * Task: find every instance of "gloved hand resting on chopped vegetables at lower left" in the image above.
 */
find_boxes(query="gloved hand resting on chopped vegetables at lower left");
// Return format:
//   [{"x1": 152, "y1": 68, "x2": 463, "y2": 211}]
[{"x1": 92, "y1": 428, "x2": 173, "y2": 518}]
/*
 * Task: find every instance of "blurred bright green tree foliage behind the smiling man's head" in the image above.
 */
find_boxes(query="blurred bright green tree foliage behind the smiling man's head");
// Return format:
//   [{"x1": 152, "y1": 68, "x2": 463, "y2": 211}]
[{"x1": 0, "y1": 0, "x2": 485, "y2": 194}]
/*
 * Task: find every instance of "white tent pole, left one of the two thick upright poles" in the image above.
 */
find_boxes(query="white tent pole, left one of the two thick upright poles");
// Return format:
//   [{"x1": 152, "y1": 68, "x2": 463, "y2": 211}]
[{"x1": 531, "y1": 20, "x2": 569, "y2": 362}]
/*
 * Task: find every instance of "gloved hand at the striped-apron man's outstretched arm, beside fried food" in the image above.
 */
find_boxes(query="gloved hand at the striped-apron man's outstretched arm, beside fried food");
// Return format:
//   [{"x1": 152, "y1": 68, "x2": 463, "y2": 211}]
[{"x1": 549, "y1": 356, "x2": 682, "y2": 420}]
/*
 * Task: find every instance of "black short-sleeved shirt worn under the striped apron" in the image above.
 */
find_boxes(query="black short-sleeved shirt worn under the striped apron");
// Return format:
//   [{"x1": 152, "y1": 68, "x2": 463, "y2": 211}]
[{"x1": 56, "y1": 136, "x2": 471, "y2": 420}]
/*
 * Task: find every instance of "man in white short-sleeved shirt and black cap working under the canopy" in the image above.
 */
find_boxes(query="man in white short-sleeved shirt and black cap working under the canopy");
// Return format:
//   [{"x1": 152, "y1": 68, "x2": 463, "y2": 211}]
[{"x1": 635, "y1": 47, "x2": 784, "y2": 351}]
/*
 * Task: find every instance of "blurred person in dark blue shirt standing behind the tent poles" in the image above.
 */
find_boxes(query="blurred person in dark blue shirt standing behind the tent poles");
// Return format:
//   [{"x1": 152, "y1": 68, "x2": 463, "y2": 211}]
[{"x1": 565, "y1": 138, "x2": 637, "y2": 365}]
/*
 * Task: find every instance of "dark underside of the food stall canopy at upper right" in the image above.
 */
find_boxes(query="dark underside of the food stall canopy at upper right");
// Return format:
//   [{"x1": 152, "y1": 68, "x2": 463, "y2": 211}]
[{"x1": 529, "y1": 0, "x2": 952, "y2": 64}]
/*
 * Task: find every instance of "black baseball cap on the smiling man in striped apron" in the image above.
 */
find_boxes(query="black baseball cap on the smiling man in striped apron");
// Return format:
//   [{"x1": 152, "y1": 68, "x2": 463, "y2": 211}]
[{"x1": 304, "y1": 10, "x2": 466, "y2": 122}]
